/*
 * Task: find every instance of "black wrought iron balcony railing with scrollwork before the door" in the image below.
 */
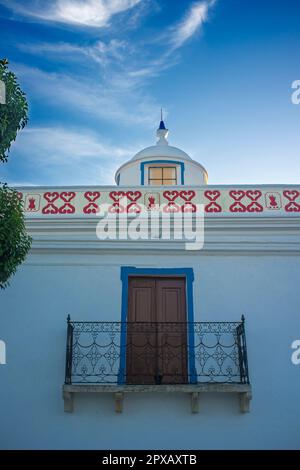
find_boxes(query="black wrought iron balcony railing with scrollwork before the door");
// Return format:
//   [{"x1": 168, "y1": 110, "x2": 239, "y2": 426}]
[{"x1": 65, "y1": 316, "x2": 249, "y2": 385}]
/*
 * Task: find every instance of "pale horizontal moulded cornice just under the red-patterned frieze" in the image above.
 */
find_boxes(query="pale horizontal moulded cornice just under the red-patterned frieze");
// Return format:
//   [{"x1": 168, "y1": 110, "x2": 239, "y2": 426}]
[{"x1": 26, "y1": 216, "x2": 300, "y2": 255}]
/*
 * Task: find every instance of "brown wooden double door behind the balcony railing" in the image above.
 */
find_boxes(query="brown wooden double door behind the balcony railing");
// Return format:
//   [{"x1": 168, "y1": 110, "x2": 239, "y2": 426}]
[{"x1": 126, "y1": 277, "x2": 187, "y2": 384}]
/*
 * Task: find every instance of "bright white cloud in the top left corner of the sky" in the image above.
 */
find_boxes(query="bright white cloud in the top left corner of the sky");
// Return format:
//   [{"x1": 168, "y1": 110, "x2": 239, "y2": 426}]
[{"x1": 1, "y1": 0, "x2": 142, "y2": 28}]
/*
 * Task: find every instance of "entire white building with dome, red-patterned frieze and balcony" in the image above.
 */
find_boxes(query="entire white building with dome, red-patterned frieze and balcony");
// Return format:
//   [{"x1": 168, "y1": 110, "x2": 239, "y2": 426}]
[{"x1": 0, "y1": 121, "x2": 300, "y2": 449}]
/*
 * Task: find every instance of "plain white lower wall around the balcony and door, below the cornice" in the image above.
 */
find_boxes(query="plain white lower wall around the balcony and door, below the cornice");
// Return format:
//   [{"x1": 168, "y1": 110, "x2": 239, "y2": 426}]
[{"x1": 0, "y1": 251, "x2": 300, "y2": 449}]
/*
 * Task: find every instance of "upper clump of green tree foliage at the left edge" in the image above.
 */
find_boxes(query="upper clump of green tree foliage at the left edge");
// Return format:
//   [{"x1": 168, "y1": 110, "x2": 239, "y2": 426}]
[{"x1": 0, "y1": 59, "x2": 28, "y2": 162}]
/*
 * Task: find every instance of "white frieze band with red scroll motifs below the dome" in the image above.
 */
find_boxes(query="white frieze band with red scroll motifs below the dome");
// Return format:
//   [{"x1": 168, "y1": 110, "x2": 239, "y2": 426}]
[{"x1": 19, "y1": 186, "x2": 300, "y2": 217}]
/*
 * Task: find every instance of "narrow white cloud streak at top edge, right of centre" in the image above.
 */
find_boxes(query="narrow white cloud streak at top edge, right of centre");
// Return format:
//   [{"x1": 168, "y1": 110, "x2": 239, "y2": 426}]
[{"x1": 170, "y1": 0, "x2": 216, "y2": 49}]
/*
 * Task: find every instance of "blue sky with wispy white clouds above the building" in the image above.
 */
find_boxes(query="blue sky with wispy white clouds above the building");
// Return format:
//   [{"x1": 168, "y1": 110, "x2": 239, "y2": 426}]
[{"x1": 0, "y1": 0, "x2": 300, "y2": 185}]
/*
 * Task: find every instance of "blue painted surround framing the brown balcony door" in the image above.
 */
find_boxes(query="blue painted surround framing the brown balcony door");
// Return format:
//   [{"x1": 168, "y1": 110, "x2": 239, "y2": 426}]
[{"x1": 118, "y1": 266, "x2": 197, "y2": 384}]
